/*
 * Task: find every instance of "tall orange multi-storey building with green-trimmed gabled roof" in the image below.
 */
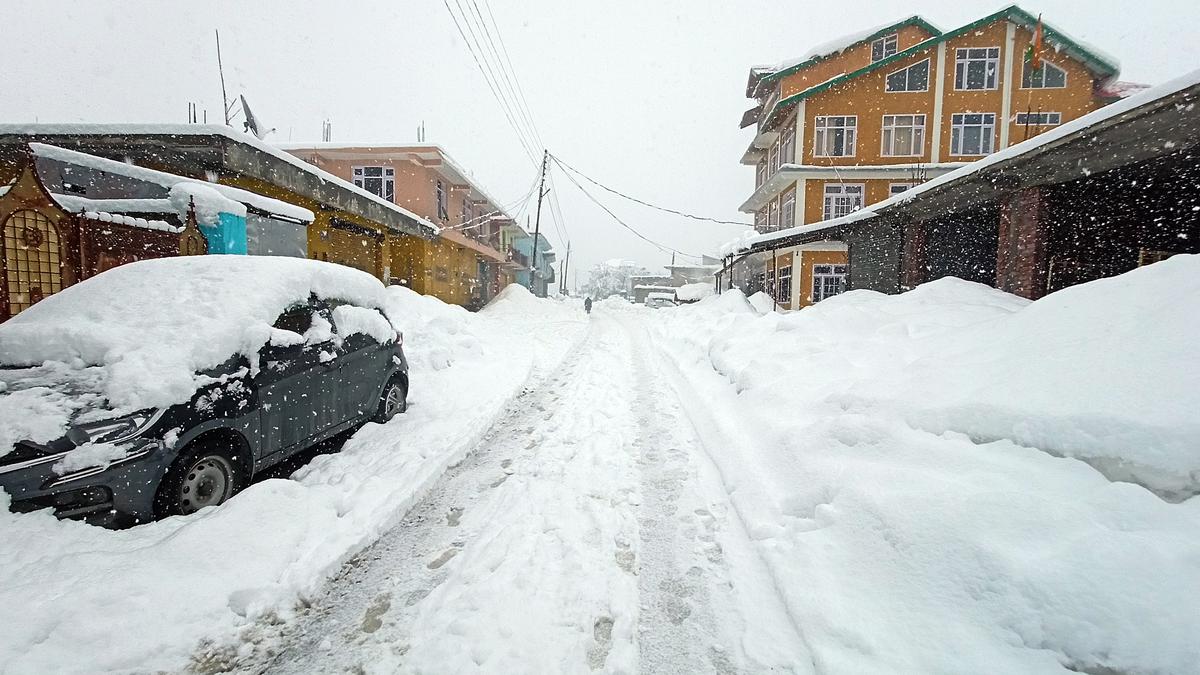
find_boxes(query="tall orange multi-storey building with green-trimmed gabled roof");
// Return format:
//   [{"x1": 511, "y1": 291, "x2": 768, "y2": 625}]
[{"x1": 742, "y1": 5, "x2": 1132, "y2": 309}]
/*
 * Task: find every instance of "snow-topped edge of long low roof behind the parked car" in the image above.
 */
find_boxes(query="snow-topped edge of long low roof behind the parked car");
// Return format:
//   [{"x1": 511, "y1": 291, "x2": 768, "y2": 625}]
[{"x1": 0, "y1": 124, "x2": 440, "y2": 234}]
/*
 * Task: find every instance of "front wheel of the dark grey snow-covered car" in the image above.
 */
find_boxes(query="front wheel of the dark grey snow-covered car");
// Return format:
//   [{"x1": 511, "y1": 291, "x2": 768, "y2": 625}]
[{"x1": 154, "y1": 438, "x2": 248, "y2": 518}]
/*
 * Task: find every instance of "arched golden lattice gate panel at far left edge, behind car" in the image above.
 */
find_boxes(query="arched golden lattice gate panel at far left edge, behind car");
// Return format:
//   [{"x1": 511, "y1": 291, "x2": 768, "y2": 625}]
[{"x1": 4, "y1": 209, "x2": 62, "y2": 316}]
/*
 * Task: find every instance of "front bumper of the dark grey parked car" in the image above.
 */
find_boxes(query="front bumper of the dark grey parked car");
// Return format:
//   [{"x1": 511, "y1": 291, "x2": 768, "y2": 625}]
[{"x1": 0, "y1": 438, "x2": 167, "y2": 526}]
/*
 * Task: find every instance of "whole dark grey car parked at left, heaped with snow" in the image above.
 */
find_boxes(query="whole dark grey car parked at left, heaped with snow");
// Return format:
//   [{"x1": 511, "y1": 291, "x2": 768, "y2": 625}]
[{"x1": 0, "y1": 256, "x2": 408, "y2": 525}]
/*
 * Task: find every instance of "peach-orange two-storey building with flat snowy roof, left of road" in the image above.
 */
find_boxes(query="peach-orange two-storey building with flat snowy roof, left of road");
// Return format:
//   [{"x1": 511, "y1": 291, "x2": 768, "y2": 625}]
[{"x1": 280, "y1": 142, "x2": 521, "y2": 307}]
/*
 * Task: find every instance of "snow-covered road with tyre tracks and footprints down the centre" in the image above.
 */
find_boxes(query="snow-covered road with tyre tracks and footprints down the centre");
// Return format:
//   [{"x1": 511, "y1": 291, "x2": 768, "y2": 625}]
[{"x1": 231, "y1": 310, "x2": 809, "y2": 673}]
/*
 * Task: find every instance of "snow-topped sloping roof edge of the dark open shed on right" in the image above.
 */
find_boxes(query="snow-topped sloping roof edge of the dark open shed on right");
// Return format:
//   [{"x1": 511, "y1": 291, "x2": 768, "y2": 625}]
[{"x1": 727, "y1": 70, "x2": 1200, "y2": 252}]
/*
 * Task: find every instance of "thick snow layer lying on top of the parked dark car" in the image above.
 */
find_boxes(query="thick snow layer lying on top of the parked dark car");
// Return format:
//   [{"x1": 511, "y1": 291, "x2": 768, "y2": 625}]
[{"x1": 0, "y1": 256, "x2": 383, "y2": 411}]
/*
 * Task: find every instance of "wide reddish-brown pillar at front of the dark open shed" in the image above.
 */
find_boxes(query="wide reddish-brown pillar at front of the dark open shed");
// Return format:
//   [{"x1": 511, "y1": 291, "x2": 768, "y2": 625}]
[{"x1": 996, "y1": 187, "x2": 1050, "y2": 300}]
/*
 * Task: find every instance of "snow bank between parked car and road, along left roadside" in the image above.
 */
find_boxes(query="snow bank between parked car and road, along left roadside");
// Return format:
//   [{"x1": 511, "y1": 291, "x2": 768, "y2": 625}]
[{"x1": 0, "y1": 284, "x2": 586, "y2": 673}]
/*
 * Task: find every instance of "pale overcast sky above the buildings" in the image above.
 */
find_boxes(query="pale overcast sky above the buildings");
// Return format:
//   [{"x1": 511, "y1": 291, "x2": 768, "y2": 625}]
[{"x1": 0, "y1": 0, "x2": 1200, "y2": 283}]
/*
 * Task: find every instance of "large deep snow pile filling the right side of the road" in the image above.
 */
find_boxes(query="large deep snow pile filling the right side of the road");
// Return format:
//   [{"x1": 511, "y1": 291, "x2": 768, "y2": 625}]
[{"x1": 653, "y1": 256, "x2": 1200, "y2": 673}]
